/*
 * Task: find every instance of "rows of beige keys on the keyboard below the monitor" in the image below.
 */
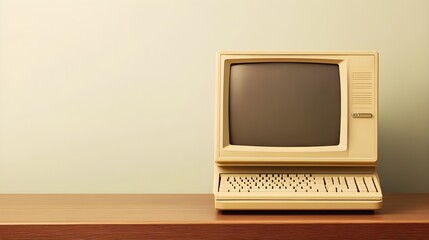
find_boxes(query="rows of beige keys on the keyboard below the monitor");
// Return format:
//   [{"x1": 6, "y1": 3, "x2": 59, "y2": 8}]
[{"x1": 218, "y1": 173, "x2": 380, "y2": 195}]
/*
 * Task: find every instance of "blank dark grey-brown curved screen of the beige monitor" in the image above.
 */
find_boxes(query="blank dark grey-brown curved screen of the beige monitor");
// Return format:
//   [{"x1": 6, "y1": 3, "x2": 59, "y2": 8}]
[{"x1": 229, "y1": 62, "x2": 341, "y2": 147}]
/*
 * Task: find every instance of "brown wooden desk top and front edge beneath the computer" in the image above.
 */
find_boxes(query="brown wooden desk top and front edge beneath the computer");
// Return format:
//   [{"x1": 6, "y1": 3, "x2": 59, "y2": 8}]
[{"x1": 0, "y1": 194, "x2": 429, "y2": 240}]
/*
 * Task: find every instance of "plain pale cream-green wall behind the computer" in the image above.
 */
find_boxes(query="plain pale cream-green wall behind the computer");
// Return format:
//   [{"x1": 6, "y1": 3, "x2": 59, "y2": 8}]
[{"x1": 0, "y1": 0, "x2": 429, "y2": 193}]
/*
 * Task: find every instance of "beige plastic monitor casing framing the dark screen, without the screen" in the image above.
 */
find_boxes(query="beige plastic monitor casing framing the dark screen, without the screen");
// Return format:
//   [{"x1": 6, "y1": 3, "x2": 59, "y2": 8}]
[{"x1": 215, "y1": 52, "x2": 378, "y2": 166}]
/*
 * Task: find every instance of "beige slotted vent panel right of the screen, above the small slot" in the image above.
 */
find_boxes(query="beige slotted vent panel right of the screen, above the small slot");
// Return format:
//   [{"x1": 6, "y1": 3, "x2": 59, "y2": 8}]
[{"x1": 352, "y1": 72, "x2": 374, "y2": 108}]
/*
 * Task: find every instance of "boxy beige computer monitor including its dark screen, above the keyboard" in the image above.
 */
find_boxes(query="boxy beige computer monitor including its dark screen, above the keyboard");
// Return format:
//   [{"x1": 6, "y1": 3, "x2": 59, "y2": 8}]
[{"x1": 215, "y1": 52, "x2": 378, "y2": 167}]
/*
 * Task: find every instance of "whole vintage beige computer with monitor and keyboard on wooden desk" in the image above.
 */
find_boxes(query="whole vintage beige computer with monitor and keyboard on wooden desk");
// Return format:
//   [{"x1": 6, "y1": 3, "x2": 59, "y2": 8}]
[{"x1": 214, "y1": 51, "x2": 382, "y2": 210}]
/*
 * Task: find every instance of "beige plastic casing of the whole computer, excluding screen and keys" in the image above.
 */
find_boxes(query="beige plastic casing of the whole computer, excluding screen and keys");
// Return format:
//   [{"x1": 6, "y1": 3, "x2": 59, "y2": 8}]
[{"x1": 213, "y1": 51, "x2": 382, "y2": 209}]
